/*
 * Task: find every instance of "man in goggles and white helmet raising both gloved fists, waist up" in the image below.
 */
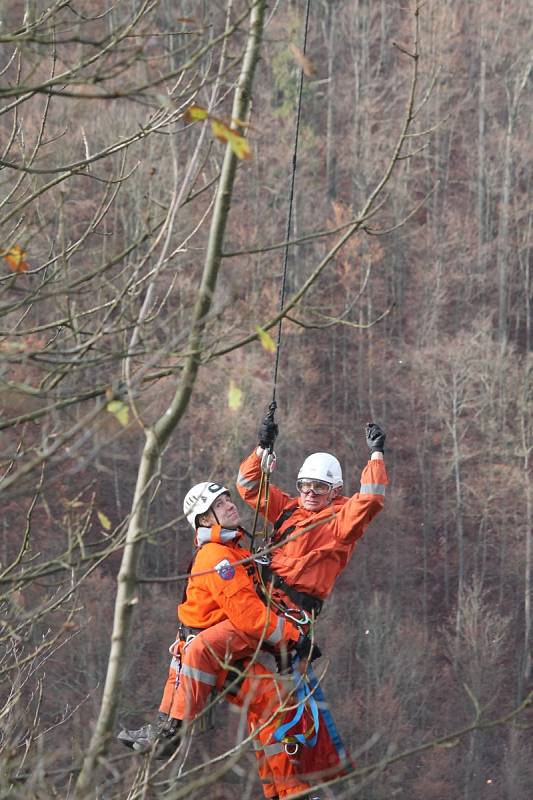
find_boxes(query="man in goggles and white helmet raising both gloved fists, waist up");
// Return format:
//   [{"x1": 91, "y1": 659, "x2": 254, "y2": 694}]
[{"x1": 237, "y1": 412, "x2": 388, "y2": 613}]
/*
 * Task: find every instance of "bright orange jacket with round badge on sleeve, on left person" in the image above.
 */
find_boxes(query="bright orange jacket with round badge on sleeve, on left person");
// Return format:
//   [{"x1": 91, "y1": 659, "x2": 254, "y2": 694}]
[{"x1": 178, "y1": 525, "x2": 299, "y2": 646}]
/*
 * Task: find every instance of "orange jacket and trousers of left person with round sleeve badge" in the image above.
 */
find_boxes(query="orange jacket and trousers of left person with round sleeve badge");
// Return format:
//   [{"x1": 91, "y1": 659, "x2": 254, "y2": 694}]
[{"x1": 159, "y1": 525, "x2": 309, "y2": 798}]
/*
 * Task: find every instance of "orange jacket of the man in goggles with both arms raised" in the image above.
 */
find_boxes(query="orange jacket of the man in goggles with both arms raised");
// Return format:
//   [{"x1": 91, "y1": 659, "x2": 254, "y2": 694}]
[{"x1": 237, "y1": 450, "x2": 388, "y2": 599}]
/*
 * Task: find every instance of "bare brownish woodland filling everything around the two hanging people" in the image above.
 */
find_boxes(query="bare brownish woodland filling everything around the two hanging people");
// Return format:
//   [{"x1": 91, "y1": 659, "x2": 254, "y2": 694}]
[{"x1": 0, "y1": 0, "x2": 533, "y2": 800}]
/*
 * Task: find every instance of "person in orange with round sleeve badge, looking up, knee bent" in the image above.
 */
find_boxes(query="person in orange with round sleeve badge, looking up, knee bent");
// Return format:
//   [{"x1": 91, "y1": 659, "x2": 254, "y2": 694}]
[{"x1": 118, "y1": 481, "x2": 324, "y2": 797}]
